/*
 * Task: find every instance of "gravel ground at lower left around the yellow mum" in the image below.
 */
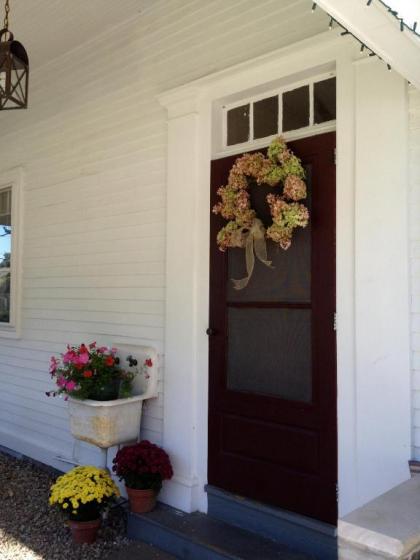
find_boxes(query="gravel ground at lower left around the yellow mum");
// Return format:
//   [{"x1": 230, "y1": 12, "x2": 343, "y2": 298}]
[{"x1": 0, "y1": 452, "x2": 141, "y2": 560}]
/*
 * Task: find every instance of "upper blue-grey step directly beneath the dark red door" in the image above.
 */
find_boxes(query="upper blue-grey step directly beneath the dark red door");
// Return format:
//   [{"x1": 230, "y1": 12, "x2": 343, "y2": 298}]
[{"x1": 206, "y1": 486, "x2": 337, "y2": 560}]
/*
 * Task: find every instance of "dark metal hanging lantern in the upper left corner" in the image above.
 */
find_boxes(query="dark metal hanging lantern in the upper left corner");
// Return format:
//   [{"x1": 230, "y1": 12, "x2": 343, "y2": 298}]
[{"x1": 0, "y1": 0, "x2": 29, "y2": 111}]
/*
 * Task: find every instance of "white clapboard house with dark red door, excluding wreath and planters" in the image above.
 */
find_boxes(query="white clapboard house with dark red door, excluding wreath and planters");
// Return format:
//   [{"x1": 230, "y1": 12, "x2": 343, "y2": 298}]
[{"x1": 0, "y1": 0, "x2": 420, "y2": 560}]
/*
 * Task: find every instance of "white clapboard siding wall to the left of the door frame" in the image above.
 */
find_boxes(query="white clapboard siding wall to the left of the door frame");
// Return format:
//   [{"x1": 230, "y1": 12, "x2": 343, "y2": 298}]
[{"x1": 0, "y1": 0, "x2": 328, "y2": 468}]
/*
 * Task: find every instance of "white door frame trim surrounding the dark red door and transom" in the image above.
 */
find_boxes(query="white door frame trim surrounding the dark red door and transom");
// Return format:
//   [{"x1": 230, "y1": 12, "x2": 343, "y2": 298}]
[{"x1": 158, "y1": 32, "x2": 410, "y2": 516}]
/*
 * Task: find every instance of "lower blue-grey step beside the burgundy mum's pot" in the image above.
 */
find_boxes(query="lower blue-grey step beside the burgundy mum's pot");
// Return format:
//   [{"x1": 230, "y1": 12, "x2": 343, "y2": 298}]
[{"x1": 127, "y1": 505, "x2": 314, "y2": 560}]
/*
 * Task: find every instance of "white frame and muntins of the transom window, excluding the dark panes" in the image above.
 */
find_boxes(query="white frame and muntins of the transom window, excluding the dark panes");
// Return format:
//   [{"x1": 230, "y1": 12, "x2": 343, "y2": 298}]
[{"x1": 221, "y1": 70, "x2": 337, "y2": 157}]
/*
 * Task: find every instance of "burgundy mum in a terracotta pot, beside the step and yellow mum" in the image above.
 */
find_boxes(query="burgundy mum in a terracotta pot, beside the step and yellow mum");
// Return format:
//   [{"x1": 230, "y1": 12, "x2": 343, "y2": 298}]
[{"x1": 112, "y1": 440, "x2": 173, "y2": 513}]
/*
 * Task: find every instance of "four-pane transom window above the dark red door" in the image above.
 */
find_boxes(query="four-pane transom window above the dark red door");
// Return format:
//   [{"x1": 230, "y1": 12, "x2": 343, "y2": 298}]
[{"x1": 222, "y1": 73, "x2": 336, "y2": 150}]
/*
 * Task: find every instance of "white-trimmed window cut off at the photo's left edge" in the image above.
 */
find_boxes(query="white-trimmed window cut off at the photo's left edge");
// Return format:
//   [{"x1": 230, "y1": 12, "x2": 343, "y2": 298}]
[{"x1": 0, "y1": 170, "x2": 22, "y2": 337}]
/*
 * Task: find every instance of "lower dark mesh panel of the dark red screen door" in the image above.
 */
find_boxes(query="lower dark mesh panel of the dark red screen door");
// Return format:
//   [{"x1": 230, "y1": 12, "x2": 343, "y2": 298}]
[{"x1": 227, "y1": 307, "x2": 312, "y2": 402}]
